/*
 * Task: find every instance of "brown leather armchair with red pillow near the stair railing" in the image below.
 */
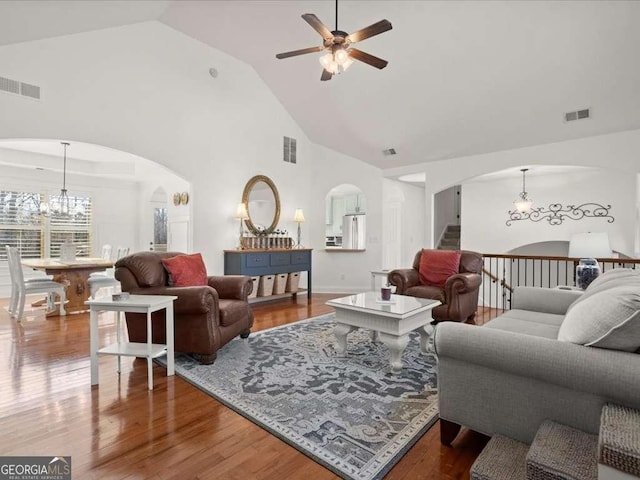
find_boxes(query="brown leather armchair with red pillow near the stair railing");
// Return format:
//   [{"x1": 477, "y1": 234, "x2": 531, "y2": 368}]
[{"x1": 387, "y1": 250, "x2": 483, "y2": 322}]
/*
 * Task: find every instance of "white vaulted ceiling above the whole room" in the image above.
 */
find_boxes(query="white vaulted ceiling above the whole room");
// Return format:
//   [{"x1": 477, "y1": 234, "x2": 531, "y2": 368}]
[{"x1": 0, "y1": 0, "x2": 640, "y2": 172}]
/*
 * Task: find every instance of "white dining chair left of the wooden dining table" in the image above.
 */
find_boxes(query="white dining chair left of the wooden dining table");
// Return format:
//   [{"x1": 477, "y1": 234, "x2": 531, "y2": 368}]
[{"x1": 5, "y1": 245, "x2": 67, "y2": 321}]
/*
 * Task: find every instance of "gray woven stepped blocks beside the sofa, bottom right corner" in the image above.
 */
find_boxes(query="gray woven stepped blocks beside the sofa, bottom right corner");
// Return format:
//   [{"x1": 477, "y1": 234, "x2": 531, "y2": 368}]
[{"x1": 471, "y1": 404, "x2": 640, "y2": 480}]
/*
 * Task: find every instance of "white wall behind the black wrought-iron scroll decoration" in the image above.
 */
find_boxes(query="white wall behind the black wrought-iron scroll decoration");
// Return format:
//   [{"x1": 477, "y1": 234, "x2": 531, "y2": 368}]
[{"x1": 461, "y1": 167, "x2": 636, "y2": 255}]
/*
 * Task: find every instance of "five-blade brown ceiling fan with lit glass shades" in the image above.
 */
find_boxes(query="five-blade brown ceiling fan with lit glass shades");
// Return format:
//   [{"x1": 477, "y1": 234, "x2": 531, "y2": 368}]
[{"x1": 276, "y1": 0, "x2": 392, "y2": 81}]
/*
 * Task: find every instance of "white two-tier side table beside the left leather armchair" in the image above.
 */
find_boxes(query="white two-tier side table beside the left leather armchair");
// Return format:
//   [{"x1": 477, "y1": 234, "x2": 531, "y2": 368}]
[{"x1": 85, "y1": 295, "x2": 178, "y2": 390}]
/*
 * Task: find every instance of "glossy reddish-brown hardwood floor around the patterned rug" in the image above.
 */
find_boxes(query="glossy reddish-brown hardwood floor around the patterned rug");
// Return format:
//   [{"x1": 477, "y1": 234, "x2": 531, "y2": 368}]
[{"x1": 0, "y1": 294, "x2": 487, "y2": 480}]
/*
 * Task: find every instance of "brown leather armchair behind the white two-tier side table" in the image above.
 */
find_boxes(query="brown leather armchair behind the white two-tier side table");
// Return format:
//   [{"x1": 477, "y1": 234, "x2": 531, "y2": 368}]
[{"x1": 115, "y1": 252, "x2": 253, "y2": 364}]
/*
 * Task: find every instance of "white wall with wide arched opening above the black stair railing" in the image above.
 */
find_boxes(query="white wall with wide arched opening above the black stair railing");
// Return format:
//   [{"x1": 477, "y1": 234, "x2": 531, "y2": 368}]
[{"x1": 384, "y1": 130, "x2": 640, "y2": 256}]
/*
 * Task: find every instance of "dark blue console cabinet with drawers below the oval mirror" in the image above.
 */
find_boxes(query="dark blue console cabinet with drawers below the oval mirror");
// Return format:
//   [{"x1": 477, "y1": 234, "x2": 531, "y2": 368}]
[{"x1": 224, "y1": 248, "x2": 311, "y2": 298}]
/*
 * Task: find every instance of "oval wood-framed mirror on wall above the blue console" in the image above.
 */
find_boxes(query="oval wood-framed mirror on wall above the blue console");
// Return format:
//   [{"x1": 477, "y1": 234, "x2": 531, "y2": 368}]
[{"x1": 242, "y1": 175, "x2": 280, "y2": 235}]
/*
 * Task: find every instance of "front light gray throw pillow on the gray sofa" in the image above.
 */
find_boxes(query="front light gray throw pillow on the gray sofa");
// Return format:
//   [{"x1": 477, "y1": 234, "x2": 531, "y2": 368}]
[{"x1": 558, "y1": 285, "x2": 640, "y2": 352}]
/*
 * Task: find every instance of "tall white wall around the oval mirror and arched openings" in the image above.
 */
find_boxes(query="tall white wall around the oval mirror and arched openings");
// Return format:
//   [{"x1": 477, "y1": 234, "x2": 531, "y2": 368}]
[{"x1": 0, "y1": 22, "x2": 390, "y2": 290}]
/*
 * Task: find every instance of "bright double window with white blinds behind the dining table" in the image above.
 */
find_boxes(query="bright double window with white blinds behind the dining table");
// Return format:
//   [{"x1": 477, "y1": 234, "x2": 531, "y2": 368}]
[{"x1": 0, "y1": 190, "x2": 92, "y2": 260}]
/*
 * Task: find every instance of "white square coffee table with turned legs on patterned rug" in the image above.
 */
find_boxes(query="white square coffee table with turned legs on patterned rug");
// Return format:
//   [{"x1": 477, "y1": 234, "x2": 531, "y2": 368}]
[{"x1": 327, "y1": 292, "x2": 440, "y2": 372}]
